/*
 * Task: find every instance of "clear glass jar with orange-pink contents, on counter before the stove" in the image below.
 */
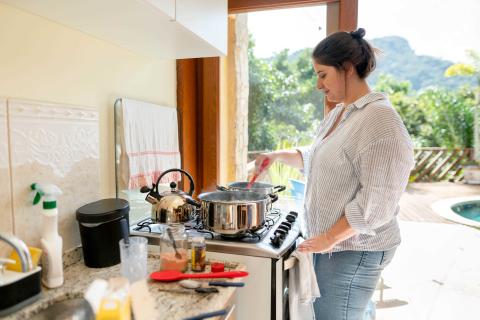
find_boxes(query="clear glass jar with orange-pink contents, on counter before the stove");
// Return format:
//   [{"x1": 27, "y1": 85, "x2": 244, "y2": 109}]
[{"x1": 160, "y1": 224, "x2": 188, "y2": 272}]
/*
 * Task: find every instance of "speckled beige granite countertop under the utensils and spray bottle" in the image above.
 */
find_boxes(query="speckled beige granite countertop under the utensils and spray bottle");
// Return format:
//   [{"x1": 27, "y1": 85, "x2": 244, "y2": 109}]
[{"x1": 6, "y1": 250, "x2": 245, "y2": 320}]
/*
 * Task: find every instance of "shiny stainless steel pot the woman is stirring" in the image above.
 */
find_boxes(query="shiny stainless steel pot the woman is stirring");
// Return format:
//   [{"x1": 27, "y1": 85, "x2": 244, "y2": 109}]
[{"x1": 198, "y1": 191, "x2": 273, "y2": 236}]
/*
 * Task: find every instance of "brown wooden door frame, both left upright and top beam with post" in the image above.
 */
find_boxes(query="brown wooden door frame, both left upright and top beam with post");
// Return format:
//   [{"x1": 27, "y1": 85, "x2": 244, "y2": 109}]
[{"x1": 177, "y1": 0, "x2": 358, "y2": 194}]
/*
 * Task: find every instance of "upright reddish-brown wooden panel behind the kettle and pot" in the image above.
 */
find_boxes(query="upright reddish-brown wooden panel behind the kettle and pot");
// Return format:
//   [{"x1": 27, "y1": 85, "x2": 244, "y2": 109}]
[{"x1": 177, "y1": 57, "x2": 220, "y2": 194}]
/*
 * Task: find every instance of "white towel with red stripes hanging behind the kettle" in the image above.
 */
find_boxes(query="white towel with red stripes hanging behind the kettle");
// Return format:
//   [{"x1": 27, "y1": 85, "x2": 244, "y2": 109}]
[{"x1": 115, "y1": 99, "x2": 180, "y2": 189}]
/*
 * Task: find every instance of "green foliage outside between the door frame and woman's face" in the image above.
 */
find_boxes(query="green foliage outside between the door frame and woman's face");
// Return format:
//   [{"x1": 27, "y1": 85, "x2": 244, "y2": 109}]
[{"x1": 248, "y1": 39, "x2": 323, "y2": 150}]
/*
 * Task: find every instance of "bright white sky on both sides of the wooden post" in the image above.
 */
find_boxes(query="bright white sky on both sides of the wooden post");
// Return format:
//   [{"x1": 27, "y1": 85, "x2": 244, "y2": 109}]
[{"x1": 248, "y1": 0, "x2": 480, "y2": 62}]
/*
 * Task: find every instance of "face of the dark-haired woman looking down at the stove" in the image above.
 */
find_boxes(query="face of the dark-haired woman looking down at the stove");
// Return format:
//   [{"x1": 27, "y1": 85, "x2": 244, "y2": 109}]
[{"x1": 313, "y1": 61, "x2": 345, "y2": 102}]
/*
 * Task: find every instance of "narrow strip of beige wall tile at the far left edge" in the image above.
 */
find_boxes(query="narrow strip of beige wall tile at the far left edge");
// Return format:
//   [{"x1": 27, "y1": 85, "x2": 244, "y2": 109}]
[{"x1": 0, "y1": 98, "x2": 13, "y2": 233}]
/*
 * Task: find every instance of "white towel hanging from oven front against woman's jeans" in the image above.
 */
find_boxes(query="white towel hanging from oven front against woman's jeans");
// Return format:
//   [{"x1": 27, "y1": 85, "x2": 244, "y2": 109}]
[{"x1": 288, "y1": 250, "x2": 320, "y2": 320}]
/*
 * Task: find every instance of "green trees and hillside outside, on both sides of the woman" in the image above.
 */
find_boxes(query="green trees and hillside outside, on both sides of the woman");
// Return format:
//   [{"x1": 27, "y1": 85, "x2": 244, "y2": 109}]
[{"x1": 248, "y1": 37, "x2": 480, "y2": 155}]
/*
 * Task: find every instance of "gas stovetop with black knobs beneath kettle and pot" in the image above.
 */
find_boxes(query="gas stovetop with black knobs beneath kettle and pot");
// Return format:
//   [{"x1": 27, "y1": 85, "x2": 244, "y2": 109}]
[{"x1": 130, "y1": 208, "x2": 300, "y2": 259}]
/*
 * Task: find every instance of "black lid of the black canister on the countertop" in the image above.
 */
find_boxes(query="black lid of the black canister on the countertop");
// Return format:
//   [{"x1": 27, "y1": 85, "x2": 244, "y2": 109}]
[{"x1": 76, "y1": 198, "x2": 130, "y2": 223}]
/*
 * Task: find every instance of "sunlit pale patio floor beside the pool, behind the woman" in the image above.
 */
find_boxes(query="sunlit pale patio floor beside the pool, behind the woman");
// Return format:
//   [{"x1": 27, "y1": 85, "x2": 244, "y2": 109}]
[{"x1": 374, "y1": 183, "x2": 480, "y2": 320}]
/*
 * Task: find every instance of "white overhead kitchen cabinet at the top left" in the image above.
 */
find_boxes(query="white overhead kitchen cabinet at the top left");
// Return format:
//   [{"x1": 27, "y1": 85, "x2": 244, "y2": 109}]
[{"x1": 0, "y1": 0, "x2": 228, "y2": 59}]
